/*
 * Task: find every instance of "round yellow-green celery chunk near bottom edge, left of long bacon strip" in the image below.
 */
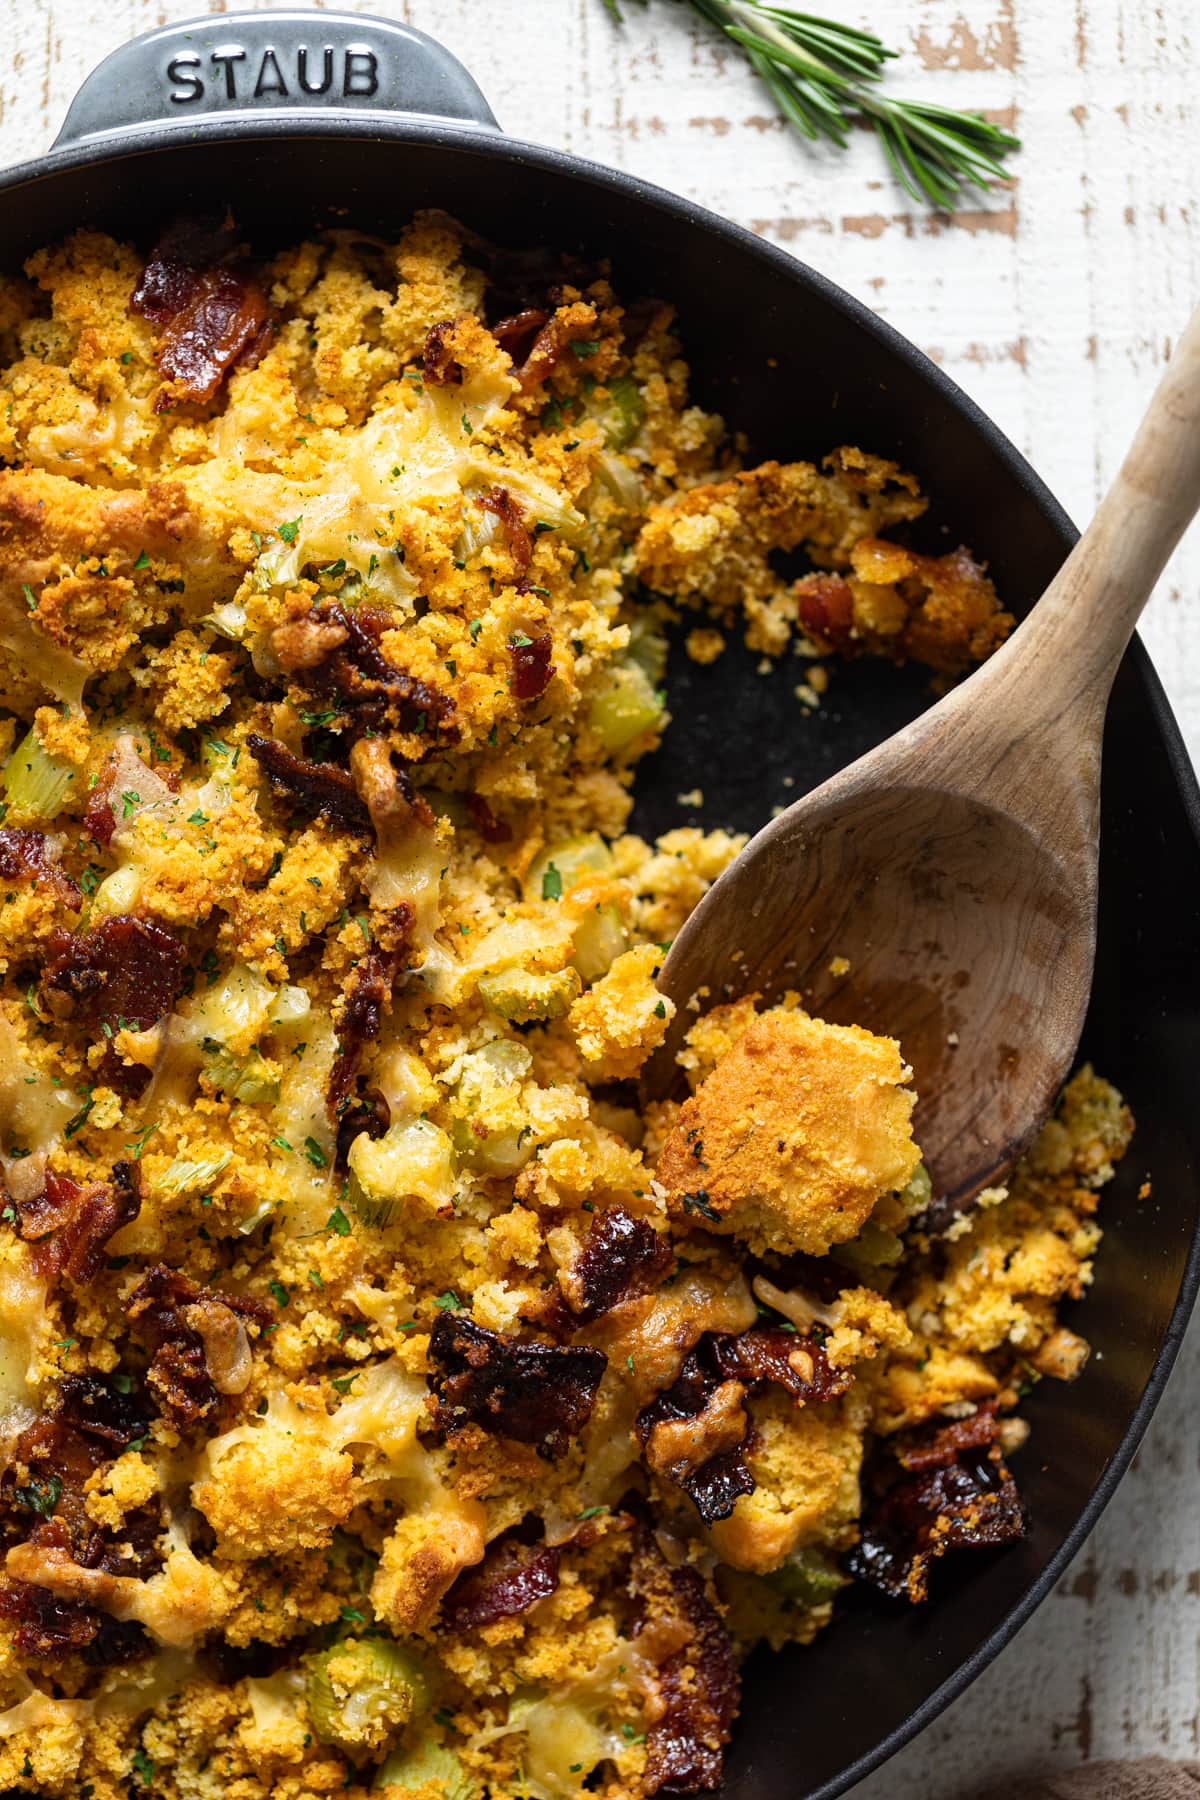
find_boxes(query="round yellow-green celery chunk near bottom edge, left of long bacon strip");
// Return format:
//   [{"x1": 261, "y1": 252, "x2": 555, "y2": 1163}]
[{"x1": 304, "y1": 1638, "x2": 430, "y2": 1762}]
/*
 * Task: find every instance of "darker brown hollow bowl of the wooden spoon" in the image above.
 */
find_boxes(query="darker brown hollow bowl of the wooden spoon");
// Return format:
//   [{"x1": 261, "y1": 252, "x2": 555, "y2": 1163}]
[{"x1": 651, "y1": 763, "x2": 1096, "y2": 1229}]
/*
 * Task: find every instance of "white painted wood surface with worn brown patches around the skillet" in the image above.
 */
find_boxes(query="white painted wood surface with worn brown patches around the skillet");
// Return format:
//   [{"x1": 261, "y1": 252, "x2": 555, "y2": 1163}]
[{"x1": 0, "y1": 0, "x2": 1200, "y2": 1800}]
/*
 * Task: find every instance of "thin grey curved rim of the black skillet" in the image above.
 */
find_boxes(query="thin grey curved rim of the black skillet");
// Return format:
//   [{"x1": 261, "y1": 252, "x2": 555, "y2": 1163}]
[{"x1": 0, "y1": 110, "x2": 1200, "y2": 1800}]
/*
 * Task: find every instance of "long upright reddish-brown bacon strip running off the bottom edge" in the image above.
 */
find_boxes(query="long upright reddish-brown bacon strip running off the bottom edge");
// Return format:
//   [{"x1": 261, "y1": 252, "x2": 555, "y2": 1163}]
[{"x1": 630, "y1": 1526, "x2": 741, "y2": 1795}]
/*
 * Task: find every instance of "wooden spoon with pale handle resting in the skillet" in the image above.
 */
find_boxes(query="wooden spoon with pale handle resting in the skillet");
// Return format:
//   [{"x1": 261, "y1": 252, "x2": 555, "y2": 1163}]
[{"x1": 646, "y1": 310, "x2": 1200, "y2": 1229}]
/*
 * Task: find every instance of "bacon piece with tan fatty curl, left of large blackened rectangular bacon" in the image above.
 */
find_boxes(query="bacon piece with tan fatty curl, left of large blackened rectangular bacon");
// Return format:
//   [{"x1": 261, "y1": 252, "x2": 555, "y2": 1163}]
[{"x1": 126, "y1": 1262, "x2": 268, "y2": 1431}]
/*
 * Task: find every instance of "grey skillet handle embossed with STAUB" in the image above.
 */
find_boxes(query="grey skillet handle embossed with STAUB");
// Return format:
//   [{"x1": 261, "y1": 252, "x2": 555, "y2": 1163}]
[{"x1": 54, "y1": 7, "x2": 498, "y2": 149}]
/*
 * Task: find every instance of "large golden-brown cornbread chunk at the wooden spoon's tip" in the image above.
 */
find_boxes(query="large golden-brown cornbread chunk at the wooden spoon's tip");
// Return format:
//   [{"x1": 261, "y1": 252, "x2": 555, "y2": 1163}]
[{"x1": 658, "y1": 1010, "x2": 921, "y2": 1256}]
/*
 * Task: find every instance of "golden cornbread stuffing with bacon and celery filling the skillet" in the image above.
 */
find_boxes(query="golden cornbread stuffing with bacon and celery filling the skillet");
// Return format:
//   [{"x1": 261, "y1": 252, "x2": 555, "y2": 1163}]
[{"x1": 0, "y1": 214, "x2": 1132, "y2": 1800}]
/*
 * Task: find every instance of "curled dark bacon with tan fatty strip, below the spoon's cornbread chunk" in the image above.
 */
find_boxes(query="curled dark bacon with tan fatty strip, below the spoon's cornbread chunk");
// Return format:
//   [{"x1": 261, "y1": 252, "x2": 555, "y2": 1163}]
[{"x1": 637, "y1": 1328, "x2": 849, "y2": 1525}]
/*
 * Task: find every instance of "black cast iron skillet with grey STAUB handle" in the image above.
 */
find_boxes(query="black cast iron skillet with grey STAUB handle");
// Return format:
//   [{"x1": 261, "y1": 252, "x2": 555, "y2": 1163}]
[{"x1": 0, "y1": 11, "x2": 1200, "y2": 1800}]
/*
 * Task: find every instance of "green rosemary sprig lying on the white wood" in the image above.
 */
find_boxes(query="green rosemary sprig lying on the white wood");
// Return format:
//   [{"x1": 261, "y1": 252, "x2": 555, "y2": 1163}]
[{"x1": 604, "y1": 0, "x2": 1020, "y2": 212}]
